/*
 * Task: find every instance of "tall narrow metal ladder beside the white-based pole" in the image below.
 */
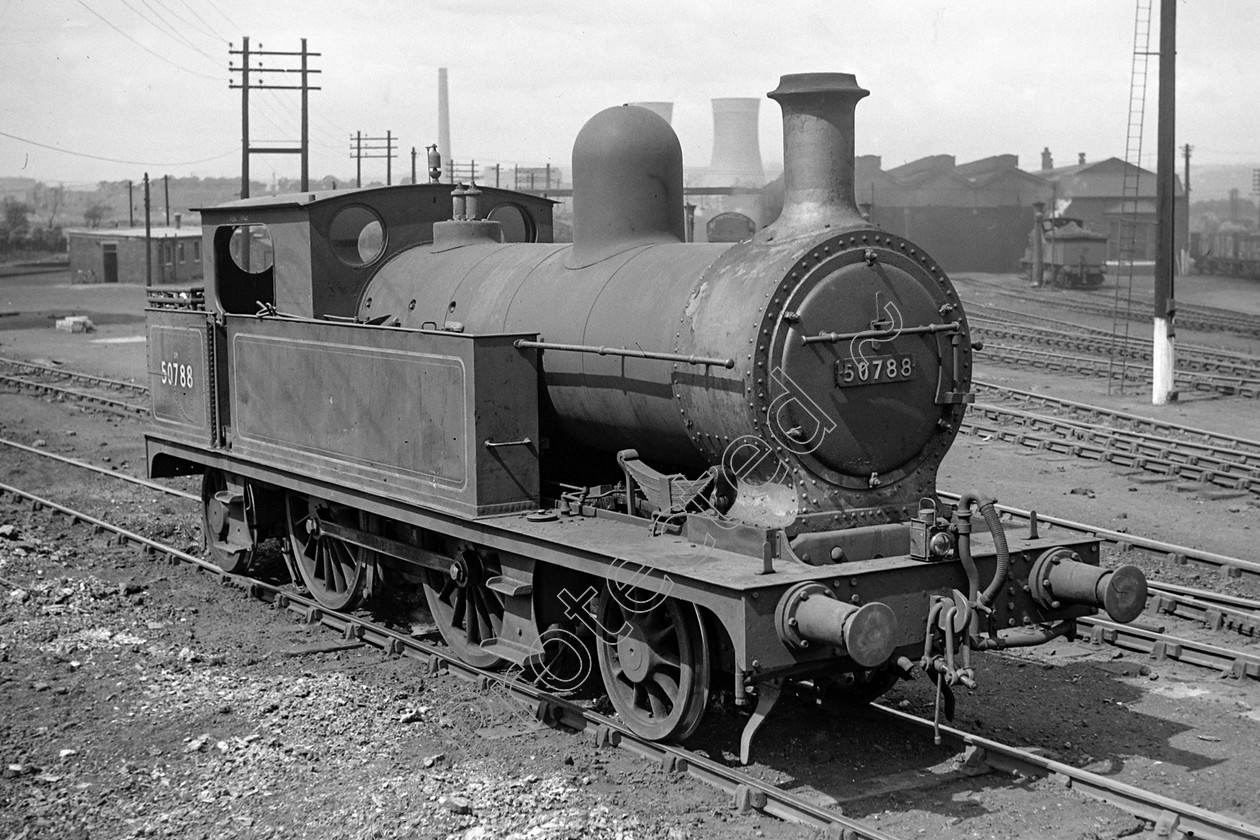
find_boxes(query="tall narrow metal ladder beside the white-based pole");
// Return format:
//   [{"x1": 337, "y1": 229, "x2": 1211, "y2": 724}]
[{"x1": 1108, "y1": 0, "x2": 1158, "y2": 394}]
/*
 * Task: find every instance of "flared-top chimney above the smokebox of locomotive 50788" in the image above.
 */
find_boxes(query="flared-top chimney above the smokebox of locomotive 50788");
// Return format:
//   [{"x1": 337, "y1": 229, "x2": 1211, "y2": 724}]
[{"x1": 766, "y1": 73, "x2": 869, "y2": 236}]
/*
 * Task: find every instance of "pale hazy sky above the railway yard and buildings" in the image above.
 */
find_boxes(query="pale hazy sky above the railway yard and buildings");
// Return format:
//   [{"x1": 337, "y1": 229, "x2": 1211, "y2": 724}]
[{"x1": 0, "y1": 0, "x2": 1260, "y2": 185}]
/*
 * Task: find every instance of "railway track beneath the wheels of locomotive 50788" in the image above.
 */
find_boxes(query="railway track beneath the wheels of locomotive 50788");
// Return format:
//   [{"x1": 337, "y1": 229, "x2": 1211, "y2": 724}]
[{"x1": 0, "y1": 484, "x2": 1260, "y2": 840}]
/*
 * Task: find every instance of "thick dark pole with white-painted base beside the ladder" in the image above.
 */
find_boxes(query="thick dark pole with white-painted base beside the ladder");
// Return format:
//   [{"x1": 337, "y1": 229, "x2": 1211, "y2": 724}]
[{"x1": 1150, "y1": 0, "x2": 1177, "y2": 406}]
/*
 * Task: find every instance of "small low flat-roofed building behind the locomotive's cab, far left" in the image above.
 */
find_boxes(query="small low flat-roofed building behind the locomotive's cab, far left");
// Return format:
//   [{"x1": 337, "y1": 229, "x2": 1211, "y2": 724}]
[{"x1": 66, "y1": 225, "x2": 203, "y2": 286}]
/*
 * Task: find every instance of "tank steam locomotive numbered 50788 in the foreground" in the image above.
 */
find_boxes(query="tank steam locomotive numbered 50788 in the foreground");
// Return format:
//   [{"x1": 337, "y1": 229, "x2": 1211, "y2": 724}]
[{"x1": 146, "y1": 73, "x2": 1145, "y2": 761}]
